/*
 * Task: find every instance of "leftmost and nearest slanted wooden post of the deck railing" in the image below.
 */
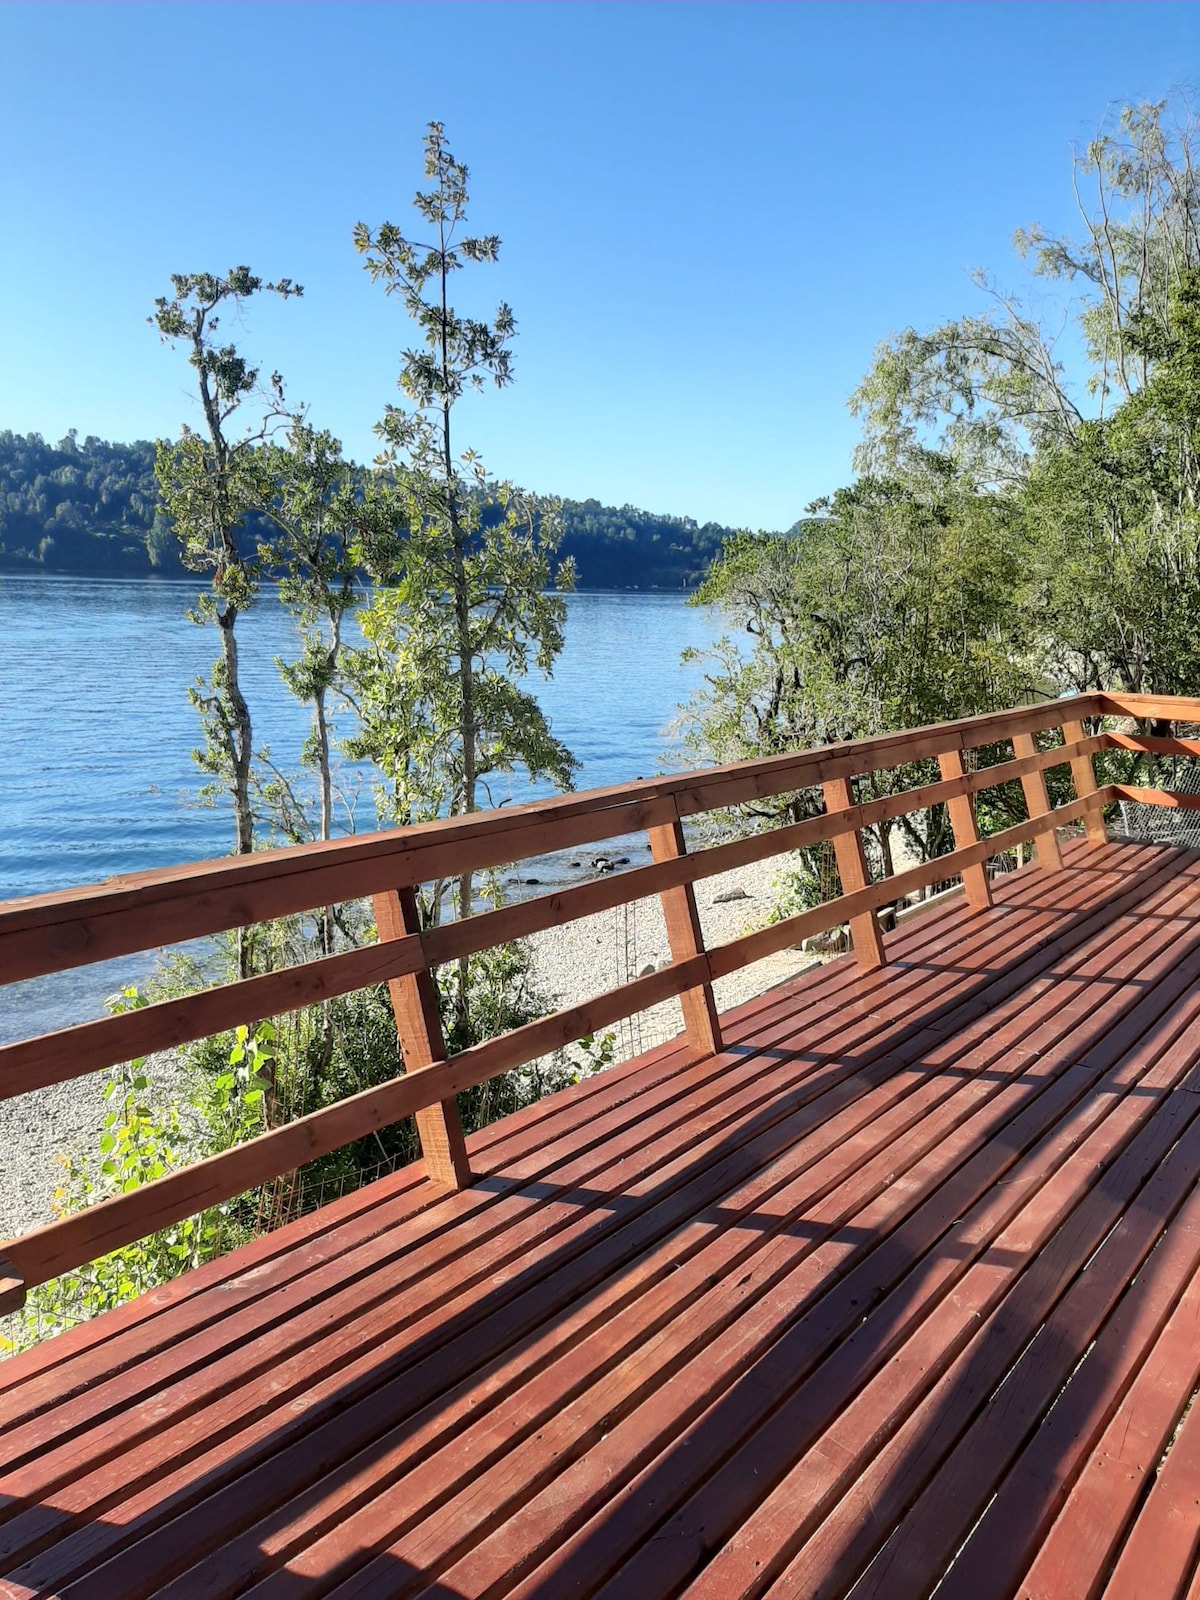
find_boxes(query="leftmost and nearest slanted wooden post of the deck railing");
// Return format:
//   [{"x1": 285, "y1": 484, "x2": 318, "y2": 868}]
[{"x1": 371, "y1": 888, "x2": 470, "y2": 1189}]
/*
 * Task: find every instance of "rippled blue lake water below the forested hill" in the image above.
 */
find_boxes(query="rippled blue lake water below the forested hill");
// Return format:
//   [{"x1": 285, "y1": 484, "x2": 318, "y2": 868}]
[{"x1": 0, "y1": 574, "x2": 717, "y2": 1038}]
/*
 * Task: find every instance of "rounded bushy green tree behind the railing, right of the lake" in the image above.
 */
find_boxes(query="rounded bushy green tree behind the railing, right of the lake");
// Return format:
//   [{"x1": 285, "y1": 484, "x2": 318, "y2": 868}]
[{"x1": 686, "y1": 456, "x2": 1029, "y2": 898}]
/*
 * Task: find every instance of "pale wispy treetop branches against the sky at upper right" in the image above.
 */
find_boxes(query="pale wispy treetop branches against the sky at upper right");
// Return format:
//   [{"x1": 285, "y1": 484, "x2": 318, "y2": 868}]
[{"x1": 851, "y1": 102, "x2": 1200, "y2": 485}]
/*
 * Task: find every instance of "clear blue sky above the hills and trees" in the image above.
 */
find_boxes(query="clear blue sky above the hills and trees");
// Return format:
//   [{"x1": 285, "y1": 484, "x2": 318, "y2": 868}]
[{"x1": 0, "y1": 0, "x2": 1200, "y2": 528}]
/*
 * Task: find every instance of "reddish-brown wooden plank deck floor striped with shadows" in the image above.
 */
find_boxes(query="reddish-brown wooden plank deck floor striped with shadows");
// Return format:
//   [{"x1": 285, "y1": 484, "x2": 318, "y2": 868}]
[{"x1": 0, "y1": 843, "x2": 1200, "y2": 1600}]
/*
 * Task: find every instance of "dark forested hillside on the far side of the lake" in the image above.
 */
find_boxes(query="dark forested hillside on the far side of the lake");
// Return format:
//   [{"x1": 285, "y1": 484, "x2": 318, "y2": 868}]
[{"x1": 0, "y1": 430, "x2": 742, "y2": 589}]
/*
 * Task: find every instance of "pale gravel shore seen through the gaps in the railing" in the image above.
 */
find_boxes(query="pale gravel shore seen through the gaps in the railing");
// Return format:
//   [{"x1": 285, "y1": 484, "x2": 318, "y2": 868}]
[{"x1": 0, "y1": 861, "x2": 811, "y2": 1238}]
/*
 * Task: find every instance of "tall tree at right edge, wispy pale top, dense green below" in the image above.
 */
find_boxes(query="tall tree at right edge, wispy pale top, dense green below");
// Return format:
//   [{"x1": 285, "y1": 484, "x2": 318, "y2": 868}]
[{"x1": 853, "y1": 93, "x2": 1200, "y2": 707}]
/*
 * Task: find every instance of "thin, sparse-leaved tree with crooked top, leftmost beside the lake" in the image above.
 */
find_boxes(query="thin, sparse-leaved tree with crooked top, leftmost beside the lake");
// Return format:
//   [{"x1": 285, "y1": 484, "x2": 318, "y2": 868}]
[{"x1": 150, "y1": 267, "x2": 302, "y2": 889}]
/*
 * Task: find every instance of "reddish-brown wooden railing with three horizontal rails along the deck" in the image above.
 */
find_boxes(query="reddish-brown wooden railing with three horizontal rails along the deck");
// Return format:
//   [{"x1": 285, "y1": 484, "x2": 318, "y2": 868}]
[{"x1": 0, "y1": 694, "x2": 1200, "y2": 1310}]
